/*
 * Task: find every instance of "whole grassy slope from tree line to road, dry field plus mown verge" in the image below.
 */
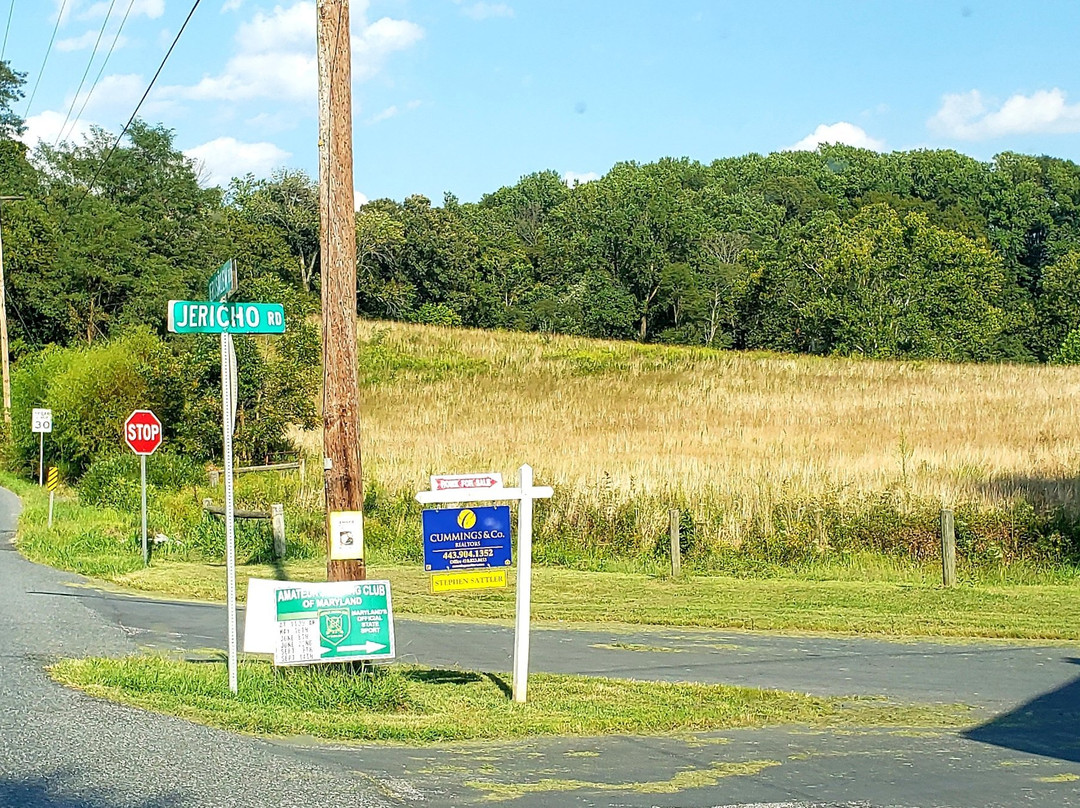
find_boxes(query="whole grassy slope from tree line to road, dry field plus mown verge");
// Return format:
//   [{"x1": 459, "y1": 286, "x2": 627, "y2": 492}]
[{"x1": 12, "y1": 323, "x2": 1080, "y2": 639}]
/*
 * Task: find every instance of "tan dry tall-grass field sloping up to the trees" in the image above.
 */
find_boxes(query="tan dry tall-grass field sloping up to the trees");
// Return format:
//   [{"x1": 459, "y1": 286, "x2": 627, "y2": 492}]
[{"x1": 291, "y1": 322, "x2": 1080, "y2": 566}]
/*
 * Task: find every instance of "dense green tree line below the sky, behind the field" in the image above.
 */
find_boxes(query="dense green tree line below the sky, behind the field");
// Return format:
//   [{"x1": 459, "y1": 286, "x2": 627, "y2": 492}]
[{"x1": 0, "y1": 63, "x2": 1080, "y2": 362}]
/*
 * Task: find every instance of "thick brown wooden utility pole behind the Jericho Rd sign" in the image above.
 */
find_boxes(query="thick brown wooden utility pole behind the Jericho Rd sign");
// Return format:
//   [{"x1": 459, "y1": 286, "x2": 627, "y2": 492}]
[{"x1": 318, "y1": 0, "x2": 365, "y2": 581}]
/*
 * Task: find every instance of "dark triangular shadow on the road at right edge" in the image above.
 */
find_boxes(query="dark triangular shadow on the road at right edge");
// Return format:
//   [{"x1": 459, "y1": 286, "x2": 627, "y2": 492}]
[{"x1": 963, "y1": 659, "x2": 1080, "y2": 763}]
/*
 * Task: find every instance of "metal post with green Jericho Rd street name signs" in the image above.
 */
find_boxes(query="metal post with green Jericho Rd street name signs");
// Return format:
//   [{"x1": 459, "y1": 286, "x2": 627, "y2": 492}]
[{"x1": 168, "y1": 264, "x2": 285, "y2": 692}]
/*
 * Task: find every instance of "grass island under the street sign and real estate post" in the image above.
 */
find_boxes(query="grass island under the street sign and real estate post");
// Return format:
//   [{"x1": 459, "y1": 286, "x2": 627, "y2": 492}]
[{"x1": 50, "y1": 657, "x2": 973, "y2": 743}]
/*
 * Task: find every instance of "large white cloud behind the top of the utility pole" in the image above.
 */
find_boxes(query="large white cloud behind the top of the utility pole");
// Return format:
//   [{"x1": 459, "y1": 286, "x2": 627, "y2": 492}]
[{"x1": 164, "y1": 0, "x2": 423, "y2": 104}]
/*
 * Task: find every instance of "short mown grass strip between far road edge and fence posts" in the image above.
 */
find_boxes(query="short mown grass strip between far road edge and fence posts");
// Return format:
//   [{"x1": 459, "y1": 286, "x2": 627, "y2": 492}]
[{"x1": 50, "y1": 561, "x2": 1080, "y2": 641}]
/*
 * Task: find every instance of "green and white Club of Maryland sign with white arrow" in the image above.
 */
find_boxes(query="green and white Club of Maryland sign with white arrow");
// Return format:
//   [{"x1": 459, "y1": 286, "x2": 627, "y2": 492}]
[{"x1": 273, "y1": 581, "x2": 394, "y2": 665}]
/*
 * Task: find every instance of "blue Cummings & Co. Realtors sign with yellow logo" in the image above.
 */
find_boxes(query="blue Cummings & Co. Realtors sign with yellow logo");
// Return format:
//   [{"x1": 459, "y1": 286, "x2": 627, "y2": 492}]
[{"x1": 423, "y1": 506, "x2": 511, "y2": 573}]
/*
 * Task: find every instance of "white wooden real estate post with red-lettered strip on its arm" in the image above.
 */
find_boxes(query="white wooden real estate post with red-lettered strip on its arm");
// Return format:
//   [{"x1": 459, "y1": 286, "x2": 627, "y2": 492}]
[{"x1": 416, "y1": 463, "x2": 555, "y2": 704}]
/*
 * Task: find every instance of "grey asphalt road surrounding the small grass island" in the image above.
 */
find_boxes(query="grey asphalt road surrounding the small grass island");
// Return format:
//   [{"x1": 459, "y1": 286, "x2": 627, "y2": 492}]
[{"x1": 0, "y1": 490, "x2": 1080, "y2": 808}]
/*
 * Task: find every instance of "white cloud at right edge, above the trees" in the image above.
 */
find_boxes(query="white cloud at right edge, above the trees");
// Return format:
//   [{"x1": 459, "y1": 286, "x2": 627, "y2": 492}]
[{"x1": 927, "y1": 87, "x2": 1080, "y2": 140}]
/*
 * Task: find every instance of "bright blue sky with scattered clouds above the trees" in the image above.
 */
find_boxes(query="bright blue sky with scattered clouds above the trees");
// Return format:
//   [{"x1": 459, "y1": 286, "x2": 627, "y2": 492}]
[{"x1": 10, "y1": 0, "x2": 1080, "y2": 202}]
